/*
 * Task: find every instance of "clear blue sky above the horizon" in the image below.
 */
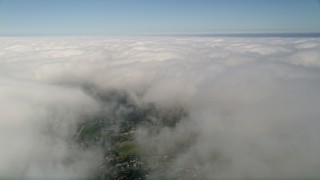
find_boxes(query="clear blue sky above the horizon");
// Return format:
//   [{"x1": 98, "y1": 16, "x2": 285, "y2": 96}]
[{"x1": 0, "y1": 0, "x2": 320, "y2": 35}]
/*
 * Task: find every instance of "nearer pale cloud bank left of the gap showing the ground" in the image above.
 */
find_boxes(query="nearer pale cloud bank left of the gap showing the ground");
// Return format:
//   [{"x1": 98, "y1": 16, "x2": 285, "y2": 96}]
[{"x1": 0, "y1": 77, "x2": 99, "y2": 178}]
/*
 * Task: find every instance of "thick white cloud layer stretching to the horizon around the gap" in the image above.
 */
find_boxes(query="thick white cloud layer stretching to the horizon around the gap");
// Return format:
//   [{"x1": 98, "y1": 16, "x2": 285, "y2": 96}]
[{"x1": 0, "y1": 37, "x2": 320, "y2": 178}]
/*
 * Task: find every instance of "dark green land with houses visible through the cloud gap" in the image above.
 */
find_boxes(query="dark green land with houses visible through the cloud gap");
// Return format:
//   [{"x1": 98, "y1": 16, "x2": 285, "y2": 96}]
[{"x1": 74, "y1": 89, "x2": 188, "y2": 179}]
